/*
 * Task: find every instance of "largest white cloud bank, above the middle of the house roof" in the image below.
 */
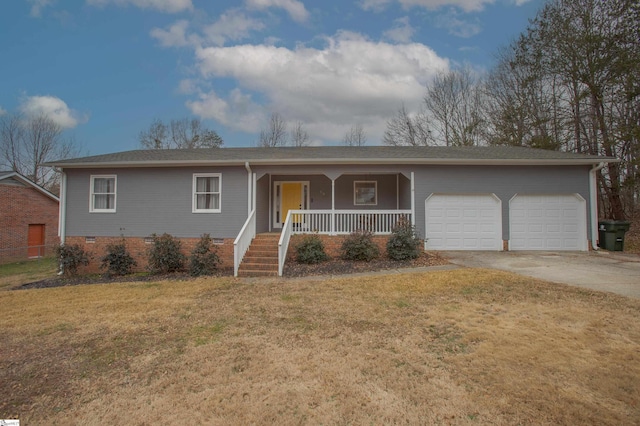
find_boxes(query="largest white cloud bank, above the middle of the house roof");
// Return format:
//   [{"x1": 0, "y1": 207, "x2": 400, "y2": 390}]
[{"x1": 188, "y1": 32, "x2": 448, "y2": 143}]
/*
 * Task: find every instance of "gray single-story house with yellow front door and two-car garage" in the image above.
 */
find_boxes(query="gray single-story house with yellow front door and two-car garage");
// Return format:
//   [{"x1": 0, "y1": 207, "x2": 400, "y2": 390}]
[{"x1": 49, "y1": 146, "x2": 617, "y2": 274}]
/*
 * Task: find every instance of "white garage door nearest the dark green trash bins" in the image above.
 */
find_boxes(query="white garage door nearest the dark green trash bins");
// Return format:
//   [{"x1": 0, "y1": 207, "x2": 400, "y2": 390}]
[{"x1": 509, "y1": 194, "x2": 587, "y2": 250}]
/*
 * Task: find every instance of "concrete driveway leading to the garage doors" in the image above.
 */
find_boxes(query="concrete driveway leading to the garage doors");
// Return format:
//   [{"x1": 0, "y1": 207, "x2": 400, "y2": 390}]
[{"x1": 441, "y1": 250, "x2": 640, "y2": 298}]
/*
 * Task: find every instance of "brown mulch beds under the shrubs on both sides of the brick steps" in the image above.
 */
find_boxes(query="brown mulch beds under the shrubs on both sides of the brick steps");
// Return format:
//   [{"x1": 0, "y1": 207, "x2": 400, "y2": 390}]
[{"x1": 21, "y1": 253, "x2": 449, "y2": 290}]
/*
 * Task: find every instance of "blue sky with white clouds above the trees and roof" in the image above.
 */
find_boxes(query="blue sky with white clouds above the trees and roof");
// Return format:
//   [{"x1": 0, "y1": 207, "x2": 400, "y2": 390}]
[{"x1": 0, "y1": 0, "x2": 544, "y2": 155}]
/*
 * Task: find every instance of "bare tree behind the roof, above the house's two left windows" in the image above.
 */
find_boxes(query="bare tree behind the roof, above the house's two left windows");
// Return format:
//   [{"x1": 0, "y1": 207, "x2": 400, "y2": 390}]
[{"x1": 138, "y1": 118, "x2": 223, "y2": 149}]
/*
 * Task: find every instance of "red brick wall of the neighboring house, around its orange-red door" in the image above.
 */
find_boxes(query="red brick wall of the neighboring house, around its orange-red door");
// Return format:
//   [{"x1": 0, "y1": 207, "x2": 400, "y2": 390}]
[{"x1": 0, "y1": 184, "x2": 59, "y2": 262}]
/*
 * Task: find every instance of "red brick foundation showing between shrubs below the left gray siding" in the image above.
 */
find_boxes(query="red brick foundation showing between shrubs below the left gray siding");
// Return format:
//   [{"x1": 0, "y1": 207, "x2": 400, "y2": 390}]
[{"x1": 65, "y1": 236, "x2": 234, "y2": 273}]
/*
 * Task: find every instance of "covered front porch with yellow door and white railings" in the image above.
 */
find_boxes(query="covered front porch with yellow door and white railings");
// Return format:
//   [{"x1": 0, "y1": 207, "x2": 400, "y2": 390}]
[{"x1": 234, "y1": 166, "x2": 415, "y2": 276}]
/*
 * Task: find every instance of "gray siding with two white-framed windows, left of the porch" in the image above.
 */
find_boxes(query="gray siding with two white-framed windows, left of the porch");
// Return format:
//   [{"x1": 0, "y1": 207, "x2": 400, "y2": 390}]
[{"x1": 66, "y1": 167, "x2": 247, "y2": 238}]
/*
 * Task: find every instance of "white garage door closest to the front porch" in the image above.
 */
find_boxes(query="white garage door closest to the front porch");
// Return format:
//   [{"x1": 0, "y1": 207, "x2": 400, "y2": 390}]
[{"x1": 425, "y1": 194, "x2": 502, "y2": 250}]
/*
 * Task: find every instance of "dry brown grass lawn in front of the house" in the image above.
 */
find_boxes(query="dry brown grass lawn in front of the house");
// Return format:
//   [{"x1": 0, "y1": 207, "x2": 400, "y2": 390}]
[{"x1": 0, "y1": 269, "x2": 640, "y2": 425}]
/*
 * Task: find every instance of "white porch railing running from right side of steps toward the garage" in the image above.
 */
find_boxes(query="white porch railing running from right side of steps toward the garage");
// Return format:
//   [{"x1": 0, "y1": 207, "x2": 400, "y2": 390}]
[{"x1": 278, "y1": 210, "x2": 411, "y2": 276}]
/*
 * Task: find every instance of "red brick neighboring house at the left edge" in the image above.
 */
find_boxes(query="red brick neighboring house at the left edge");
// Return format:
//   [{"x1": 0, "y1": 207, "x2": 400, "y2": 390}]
[{"x1": 0, "y1": 171, "x2": 59, "y2": 262}]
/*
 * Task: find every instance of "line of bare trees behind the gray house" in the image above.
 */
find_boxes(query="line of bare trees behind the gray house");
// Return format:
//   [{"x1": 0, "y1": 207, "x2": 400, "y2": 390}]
[{"x1": 0, "y1": 0, "x2": 640, "y2": 219}]
